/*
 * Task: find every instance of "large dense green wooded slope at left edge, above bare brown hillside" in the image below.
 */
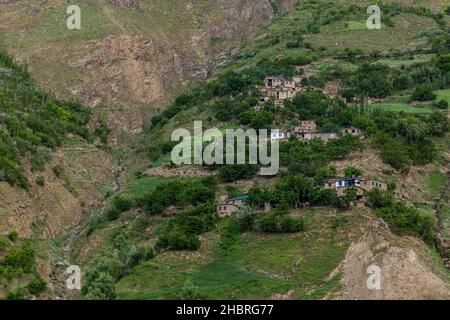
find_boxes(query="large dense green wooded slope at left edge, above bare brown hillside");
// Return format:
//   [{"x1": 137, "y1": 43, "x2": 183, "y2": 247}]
[{"x1": 0, "y1": 50, "x2": 90, "y2": 188}]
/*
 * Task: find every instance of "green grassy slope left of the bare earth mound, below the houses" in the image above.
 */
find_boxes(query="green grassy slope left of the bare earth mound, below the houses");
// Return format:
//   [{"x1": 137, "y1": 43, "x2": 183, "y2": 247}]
[{"x1": 117, "y1": 210, "x2": 359, "y2": 299}]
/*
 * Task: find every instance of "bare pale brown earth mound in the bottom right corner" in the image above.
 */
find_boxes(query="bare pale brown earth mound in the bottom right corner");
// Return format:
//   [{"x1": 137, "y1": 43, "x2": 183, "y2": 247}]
[{"x1": 326, "y1": 220, "x2": 450, "y2": 300}]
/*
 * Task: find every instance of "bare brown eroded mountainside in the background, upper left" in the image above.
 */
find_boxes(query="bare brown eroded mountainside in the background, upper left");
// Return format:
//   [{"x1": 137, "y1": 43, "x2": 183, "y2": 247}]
[{"x1": 0, "y1": 0, "x2": 295, "y2": 136}]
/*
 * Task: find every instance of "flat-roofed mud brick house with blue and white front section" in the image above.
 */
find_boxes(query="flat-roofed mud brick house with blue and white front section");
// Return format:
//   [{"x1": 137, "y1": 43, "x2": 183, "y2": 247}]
[{"x1": 324, "y1": 178, "x2": 387, "y2": 207}]
